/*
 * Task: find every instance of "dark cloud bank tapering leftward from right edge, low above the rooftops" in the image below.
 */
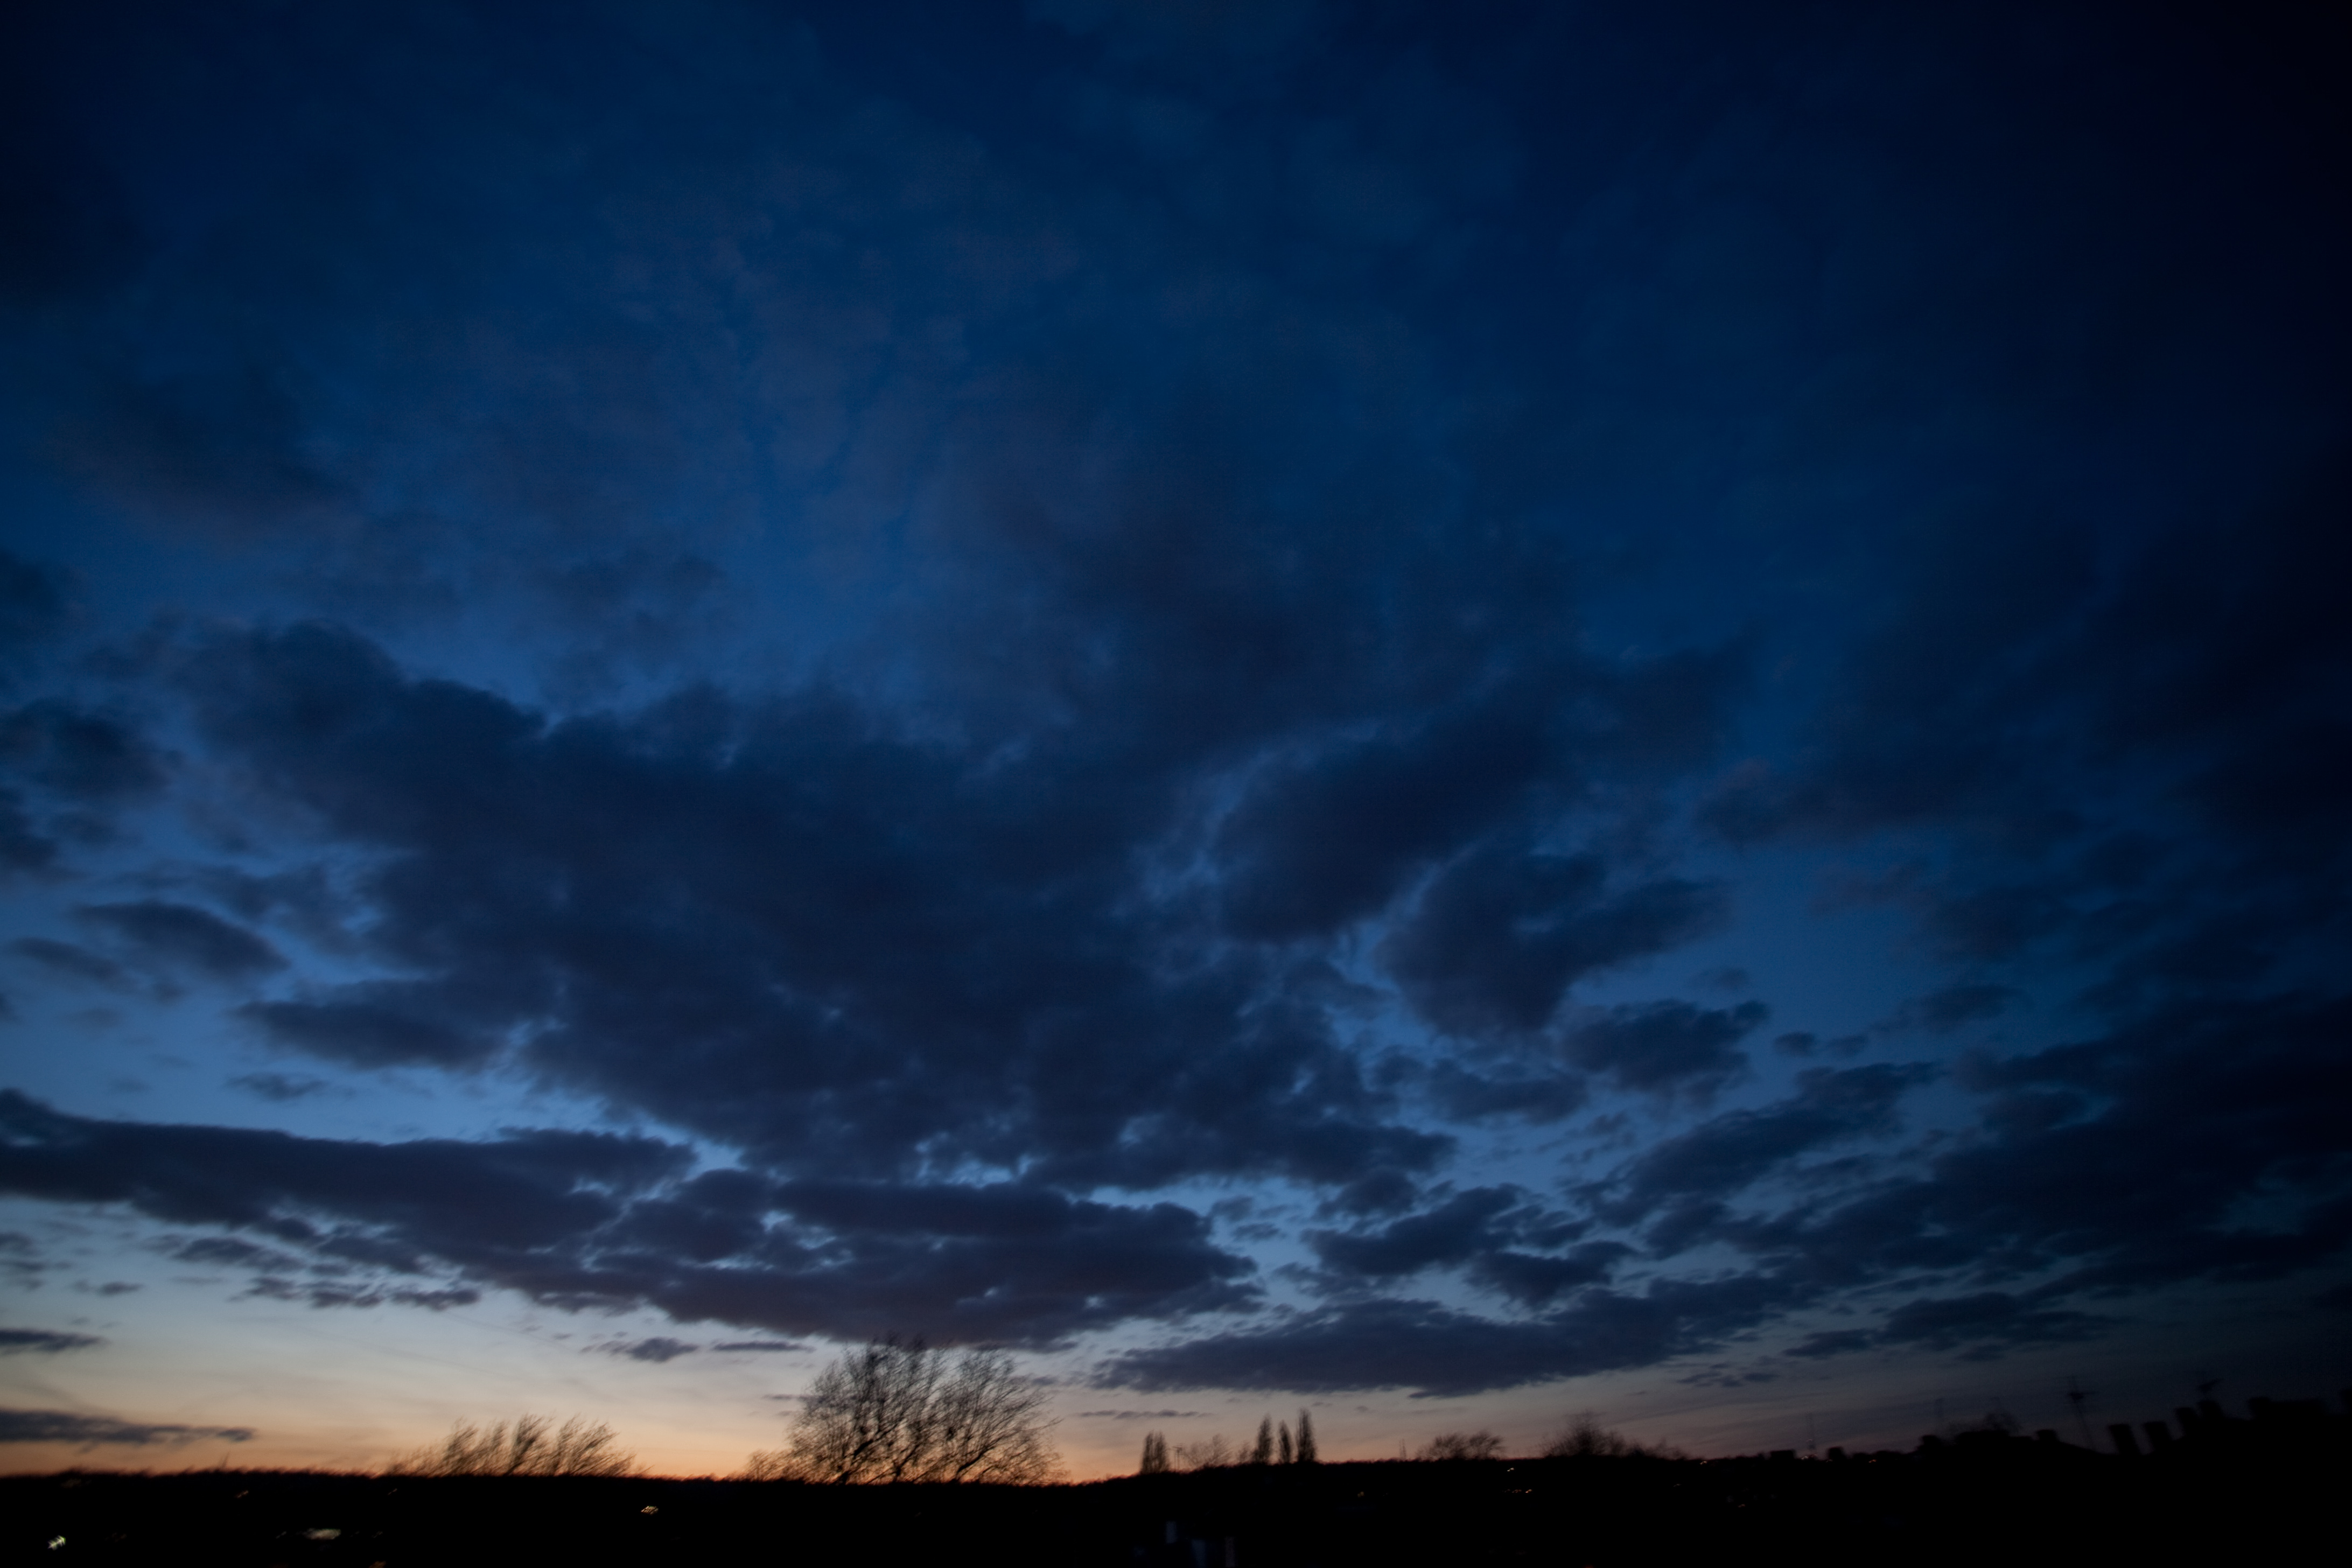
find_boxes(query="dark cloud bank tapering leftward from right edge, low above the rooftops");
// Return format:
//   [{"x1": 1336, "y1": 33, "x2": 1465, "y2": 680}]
[{"x1": 1712, "y1": 997, "x2": 2352, "y2": 1310}]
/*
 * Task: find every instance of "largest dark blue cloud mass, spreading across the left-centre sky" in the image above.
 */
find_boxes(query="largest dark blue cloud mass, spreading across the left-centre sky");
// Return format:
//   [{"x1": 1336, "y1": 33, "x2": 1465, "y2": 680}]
[{"x1": 181, "y1": 625, "x2": 1477, "y2": 1185}]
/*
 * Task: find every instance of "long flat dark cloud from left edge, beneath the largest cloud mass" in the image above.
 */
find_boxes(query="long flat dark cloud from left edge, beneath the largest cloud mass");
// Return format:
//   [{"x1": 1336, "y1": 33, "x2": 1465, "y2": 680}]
[{"x1": 0, "y1": 1091, "x2": 1254, "y2": 1354}]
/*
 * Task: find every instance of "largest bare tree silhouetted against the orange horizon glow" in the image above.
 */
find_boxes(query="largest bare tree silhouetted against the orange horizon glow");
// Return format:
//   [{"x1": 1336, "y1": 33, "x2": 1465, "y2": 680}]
[{"x1": 743, "y1": 1338, "x2": 1059, "y2": 1483}]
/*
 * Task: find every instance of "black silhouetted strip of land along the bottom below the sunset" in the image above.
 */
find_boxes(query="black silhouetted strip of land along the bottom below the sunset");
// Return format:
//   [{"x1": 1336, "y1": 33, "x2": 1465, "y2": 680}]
[{"x1": 0, "y1": 1422, "x2": 2352, "y2": 1568}]
